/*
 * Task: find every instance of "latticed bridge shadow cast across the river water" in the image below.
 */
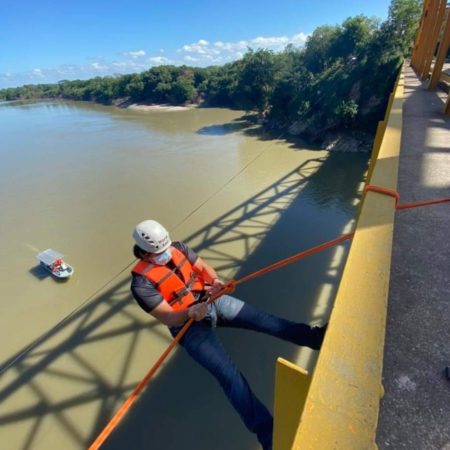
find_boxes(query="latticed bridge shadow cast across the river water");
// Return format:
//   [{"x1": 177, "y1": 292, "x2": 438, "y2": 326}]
[{"x1": 0, "y1": 147, "x2": 367, "y2": 450}]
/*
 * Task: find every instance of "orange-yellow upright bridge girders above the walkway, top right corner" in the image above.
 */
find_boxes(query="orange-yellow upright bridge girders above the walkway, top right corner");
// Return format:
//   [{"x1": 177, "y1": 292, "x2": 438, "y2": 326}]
[{"x1": 411, "y1": 0, "x2": 450, "y2": 114}]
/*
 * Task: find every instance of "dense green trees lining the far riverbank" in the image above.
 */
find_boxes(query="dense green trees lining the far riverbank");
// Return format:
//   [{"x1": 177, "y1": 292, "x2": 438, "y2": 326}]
[{"x1": 0, "y1": 0, "x2": 422, "y2": 138}]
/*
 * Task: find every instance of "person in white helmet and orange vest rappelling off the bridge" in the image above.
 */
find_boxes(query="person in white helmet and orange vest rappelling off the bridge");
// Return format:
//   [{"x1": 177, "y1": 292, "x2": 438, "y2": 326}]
[{"x1": 131, "y1": 220, "x2": 326, "y2": 450}]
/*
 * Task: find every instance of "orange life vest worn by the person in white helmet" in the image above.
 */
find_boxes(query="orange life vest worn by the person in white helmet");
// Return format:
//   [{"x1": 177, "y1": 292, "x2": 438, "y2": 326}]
[{"x1": 132, "y1": 247, "x2": 205, "y2": 311}]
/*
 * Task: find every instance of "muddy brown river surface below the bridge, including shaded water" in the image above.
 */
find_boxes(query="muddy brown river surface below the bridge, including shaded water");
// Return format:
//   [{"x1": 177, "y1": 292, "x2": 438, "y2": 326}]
[{"x1": 0, "y1": 102, "x2": 367, "y2": 450}]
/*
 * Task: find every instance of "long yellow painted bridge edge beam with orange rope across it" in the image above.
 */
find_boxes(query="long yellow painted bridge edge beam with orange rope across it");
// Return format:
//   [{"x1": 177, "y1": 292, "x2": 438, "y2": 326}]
[{"x1": 275, "y1": 68, "x2": 403, "y2": 450}]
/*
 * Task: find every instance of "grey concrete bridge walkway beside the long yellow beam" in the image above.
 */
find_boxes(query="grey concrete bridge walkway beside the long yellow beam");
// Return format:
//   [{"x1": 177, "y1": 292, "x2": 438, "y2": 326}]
[{"x1": 377, "y1": 68, "x2": 450, "y2": 450}]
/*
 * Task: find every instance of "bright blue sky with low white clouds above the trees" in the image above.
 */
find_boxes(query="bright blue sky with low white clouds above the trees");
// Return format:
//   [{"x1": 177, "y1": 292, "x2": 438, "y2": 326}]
[{"x1": 0, "y1": 0, "x2": 390, "y2": 88}]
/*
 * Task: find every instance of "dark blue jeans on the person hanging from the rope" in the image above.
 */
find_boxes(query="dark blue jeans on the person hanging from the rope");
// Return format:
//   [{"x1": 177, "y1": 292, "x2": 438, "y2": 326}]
[{"x1": 169, "y1": 295, "x2": 320, "y2": 450}]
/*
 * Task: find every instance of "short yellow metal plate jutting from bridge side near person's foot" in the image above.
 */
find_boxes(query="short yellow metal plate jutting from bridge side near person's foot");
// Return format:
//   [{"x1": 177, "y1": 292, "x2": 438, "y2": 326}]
[{"x1": 273, "y1": 358, "x2": 311, "y2": 450}]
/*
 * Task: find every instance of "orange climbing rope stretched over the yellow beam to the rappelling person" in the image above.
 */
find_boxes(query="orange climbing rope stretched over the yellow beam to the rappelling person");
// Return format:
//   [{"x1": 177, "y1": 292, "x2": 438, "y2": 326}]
[{"x1": 88, "y1": 184, "x2": 450, "y2": 450}]
